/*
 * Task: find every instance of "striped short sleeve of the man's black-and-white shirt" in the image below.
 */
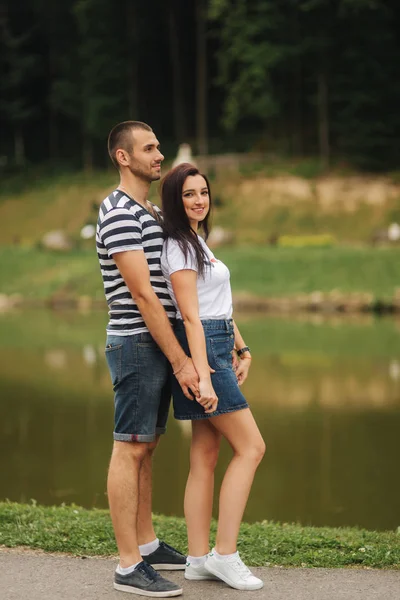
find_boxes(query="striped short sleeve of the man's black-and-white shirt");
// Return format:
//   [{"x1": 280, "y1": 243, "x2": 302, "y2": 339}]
[{"x1": 99, "y1": 207, "x2": 143, "y2": 256}]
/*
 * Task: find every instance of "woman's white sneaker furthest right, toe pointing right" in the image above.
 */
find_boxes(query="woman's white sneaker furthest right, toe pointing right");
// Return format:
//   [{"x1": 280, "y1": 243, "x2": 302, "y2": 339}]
[{"x1": 204, "y1": 550, "x2": 264, "y2": 590}]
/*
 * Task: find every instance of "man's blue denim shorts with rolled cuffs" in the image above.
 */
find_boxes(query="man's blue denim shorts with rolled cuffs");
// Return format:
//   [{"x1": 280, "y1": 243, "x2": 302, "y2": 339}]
[{"x1": 105, "y1": 332, "x2": 172, "y2": 442}]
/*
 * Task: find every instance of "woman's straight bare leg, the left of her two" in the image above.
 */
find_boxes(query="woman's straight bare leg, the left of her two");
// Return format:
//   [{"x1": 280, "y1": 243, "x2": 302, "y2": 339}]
[{"x1": 184, "y1": 419, "x2": 221, "y2": 556}]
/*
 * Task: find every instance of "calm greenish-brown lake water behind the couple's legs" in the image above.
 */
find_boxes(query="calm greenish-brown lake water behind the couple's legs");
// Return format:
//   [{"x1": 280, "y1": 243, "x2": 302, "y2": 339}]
[{"x1": 0, "y1": 310, "x2": 400, "y2": 530}]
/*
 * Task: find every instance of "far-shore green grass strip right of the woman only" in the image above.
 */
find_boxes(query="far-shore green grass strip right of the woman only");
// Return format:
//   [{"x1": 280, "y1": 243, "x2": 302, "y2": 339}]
[{"x1": 216, "y1": 246, "x2": 400, "y2": 299}]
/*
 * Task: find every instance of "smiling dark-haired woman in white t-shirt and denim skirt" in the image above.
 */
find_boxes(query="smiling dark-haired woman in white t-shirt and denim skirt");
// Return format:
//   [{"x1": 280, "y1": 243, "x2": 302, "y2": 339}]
[{"x1": 161, "y1": 163, "x2": 265, "y2": 590}]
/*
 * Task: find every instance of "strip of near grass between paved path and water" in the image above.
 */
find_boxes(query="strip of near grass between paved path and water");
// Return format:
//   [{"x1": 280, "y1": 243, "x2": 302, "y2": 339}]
[{"x1": 0, "y1": 502, "x2": 400, "y2": 568}]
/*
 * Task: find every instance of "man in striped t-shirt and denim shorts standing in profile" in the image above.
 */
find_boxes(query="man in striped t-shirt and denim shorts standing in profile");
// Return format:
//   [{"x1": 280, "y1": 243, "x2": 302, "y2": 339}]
[{"x1": 96, "y1": 121, "x2": 198, "y2": 597}]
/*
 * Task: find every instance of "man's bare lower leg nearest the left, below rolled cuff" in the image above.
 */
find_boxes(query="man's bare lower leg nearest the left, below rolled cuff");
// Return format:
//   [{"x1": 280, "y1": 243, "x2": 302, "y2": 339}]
[{"x1": 107, "y1": 441, "x2": 149, "y2": 568}]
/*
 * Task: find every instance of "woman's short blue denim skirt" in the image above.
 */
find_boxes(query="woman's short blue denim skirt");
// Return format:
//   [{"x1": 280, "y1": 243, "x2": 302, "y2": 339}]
[{"x1": 172, "y1": 319, "x2": 248, "y2": 420}]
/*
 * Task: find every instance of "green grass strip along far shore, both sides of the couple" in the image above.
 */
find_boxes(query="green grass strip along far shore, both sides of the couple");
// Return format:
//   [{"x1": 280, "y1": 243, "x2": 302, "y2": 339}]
[{"x1": 0, "y1": 246, "x2": 400, "y2": 301}]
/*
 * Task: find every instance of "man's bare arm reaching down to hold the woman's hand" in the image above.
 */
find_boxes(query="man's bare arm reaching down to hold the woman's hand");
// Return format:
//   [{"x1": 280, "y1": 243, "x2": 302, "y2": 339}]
[{"x1": 113, "y1": 250, "x2": 199, "y2": 400}]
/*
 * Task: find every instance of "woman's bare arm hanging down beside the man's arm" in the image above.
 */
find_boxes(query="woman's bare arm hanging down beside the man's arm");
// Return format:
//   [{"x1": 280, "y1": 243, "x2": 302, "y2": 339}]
[{"x1": 171, "y1": 269, "x2": 218, "y2": 413}]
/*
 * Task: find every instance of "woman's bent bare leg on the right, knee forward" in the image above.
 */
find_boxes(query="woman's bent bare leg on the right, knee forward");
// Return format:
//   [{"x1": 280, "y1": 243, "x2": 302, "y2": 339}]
[{"x1": 211, "y1": 408, "x2": 265, "y2": 554}]
